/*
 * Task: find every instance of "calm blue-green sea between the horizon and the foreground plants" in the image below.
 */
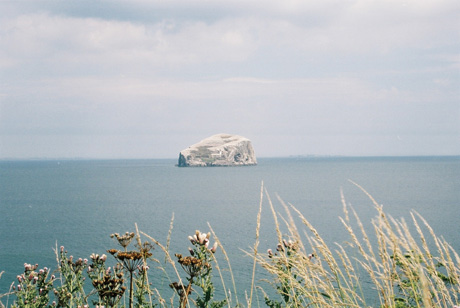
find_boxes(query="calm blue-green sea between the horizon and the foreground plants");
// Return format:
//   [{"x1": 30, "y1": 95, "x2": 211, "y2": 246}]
[{"x1": 0, "y1": 156, "x2": 460, "y2": 301}]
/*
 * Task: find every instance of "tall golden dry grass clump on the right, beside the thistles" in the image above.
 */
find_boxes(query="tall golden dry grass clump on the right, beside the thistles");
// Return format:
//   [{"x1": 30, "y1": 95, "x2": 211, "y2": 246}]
[{"x1": 255, "y1": 184, "x2": 460, "y2": 308}]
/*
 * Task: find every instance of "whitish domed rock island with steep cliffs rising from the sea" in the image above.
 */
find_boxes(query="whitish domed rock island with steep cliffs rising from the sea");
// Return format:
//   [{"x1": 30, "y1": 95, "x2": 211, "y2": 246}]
[{"x1": 178, "y1": 134, "x2": 257, "y2": 167}]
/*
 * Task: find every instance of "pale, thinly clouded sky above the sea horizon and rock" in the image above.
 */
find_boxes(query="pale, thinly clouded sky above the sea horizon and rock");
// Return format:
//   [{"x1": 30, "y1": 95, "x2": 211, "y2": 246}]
[{"x1": 0, "y1": 0, "x2": 460, "y2": 159}]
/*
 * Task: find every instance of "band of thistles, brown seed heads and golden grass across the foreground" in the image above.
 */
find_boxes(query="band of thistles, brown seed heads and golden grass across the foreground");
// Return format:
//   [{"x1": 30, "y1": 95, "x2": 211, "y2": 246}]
[{"x1": 0, "y1": 184, "x2": 460, "y2": 308}]
